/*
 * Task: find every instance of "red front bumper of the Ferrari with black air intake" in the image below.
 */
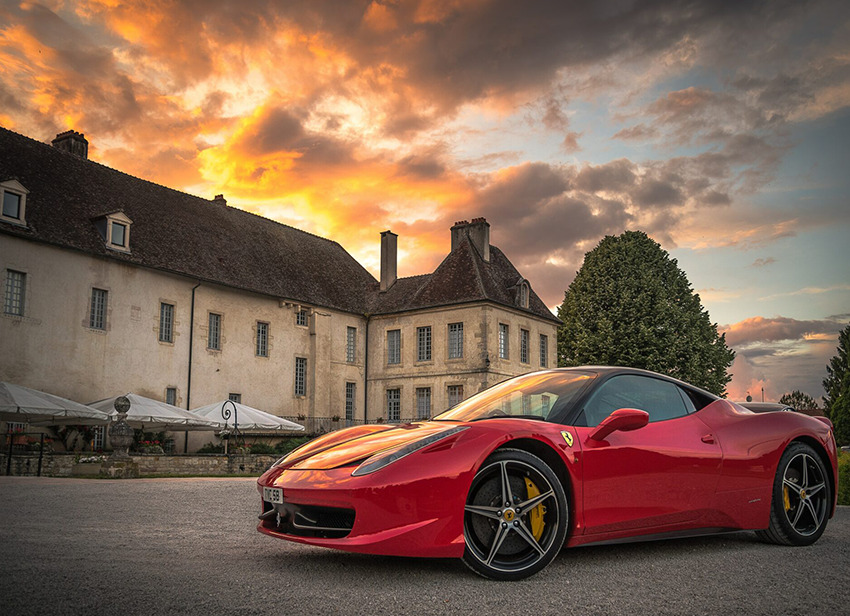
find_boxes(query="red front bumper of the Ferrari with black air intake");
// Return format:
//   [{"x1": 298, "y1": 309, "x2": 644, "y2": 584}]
[{"x1": 257, "y1": 465, "x2": 472, "y2": 558}]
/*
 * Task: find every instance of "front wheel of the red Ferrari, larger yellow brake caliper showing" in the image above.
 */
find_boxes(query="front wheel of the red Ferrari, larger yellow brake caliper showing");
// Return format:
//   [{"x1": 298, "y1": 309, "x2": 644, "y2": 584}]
[{"x1": 463, "y1": 449, "x2": 569, "y2": 580}]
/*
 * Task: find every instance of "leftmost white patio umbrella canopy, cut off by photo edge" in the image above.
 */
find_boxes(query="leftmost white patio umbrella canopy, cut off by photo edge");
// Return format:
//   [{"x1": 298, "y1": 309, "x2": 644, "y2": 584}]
[{"x1": 0, "y1": 382, "x2": 109, "y2": 425}]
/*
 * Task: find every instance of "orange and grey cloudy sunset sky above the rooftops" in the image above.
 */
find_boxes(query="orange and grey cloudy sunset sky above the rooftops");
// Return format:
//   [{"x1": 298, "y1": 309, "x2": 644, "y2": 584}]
[{"x1": 0, "y1": 0, "x2": 850, "y2": 400}]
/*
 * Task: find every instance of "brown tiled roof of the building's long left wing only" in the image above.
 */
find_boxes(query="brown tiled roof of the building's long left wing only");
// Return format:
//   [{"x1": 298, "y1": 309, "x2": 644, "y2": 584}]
[{"x1": 0, "y1": 127, "x2": 375, "y2": 313}]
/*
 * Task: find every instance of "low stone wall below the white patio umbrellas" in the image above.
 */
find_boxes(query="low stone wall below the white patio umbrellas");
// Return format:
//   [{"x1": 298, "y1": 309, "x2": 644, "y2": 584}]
[{"x1": 3, "y1": 453, "x2": 280, "y2": 477}]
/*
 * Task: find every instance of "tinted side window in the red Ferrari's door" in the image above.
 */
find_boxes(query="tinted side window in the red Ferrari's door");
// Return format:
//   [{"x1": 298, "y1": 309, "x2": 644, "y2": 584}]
[{"x1": 584, "y1": 374, "x2": 689, "y2": 427}]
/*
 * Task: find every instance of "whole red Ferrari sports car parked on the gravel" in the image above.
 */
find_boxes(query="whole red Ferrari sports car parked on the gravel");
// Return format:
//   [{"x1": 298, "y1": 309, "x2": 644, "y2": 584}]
[{"x1": 258, "y1": 367, "x2": 838, "y2": 580}]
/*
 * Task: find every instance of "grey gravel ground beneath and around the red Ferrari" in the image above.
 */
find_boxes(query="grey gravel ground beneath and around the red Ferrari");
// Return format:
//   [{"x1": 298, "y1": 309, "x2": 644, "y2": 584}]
[{"x1": 0, "y1": 477, "x2": 850, "y2": 616}]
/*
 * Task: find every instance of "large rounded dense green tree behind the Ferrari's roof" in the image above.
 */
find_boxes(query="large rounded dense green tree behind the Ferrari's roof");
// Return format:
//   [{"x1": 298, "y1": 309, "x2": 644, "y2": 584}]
[{"x1": 558, "y1": 231, "x2": 735, "y2": 395}]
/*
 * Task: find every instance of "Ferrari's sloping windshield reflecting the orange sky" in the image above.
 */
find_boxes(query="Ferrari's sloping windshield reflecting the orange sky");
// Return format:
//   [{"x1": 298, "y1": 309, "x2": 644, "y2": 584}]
[{"x1": 434, "y1": 370, "x2": 596, "y2": 421}]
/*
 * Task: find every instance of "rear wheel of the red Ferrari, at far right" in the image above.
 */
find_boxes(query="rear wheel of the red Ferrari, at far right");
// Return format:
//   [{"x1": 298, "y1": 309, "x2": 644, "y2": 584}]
[{"x1": 756, "y1": 442, "x2": 832, "y2": 545}]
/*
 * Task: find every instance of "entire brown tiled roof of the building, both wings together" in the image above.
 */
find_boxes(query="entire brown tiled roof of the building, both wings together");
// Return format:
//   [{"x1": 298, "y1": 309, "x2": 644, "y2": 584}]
[{"x1": 0, "y1": 127, "x2": 558, "y2": 322}]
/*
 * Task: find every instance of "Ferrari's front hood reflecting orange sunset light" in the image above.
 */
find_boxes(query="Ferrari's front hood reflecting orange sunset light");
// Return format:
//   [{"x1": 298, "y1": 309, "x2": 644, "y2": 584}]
[{"x1": 281, "y1": 421, "x2": 456, "y2": 470}]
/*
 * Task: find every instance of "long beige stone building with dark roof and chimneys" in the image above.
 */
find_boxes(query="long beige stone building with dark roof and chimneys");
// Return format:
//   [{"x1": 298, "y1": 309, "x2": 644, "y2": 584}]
[{"x1": 0, "y1": 128, "x2": 558, "y2": 448}]
